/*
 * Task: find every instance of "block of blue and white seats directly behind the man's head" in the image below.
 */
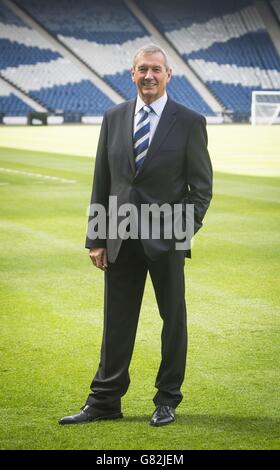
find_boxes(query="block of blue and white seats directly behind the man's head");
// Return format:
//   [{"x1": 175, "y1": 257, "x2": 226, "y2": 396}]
[{"x1": 14, "y1": 0, "x2": 215, "y2": 115}]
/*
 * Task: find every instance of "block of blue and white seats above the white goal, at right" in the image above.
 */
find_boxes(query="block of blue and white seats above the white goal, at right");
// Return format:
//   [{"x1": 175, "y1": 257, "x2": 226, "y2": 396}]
[{"x1": 137, "y1": 0, "x2": 280, "y2": 121}]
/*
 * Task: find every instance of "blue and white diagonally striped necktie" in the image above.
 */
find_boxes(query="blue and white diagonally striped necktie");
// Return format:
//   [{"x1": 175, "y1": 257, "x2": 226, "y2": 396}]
[{"x1": 133, "y1": 105, "x2": 153, "y2": 170}]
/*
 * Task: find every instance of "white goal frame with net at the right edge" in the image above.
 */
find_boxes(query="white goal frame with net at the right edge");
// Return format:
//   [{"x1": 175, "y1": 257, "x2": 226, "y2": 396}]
[{"x1": 251, "y1": 91, "x2": 280, "y2": 126}]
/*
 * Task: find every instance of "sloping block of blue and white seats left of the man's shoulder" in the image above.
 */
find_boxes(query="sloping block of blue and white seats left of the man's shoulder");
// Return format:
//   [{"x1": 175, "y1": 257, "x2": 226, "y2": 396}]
[{"x1": 0, "y1": 0, "x2": 114, "y2": 115}]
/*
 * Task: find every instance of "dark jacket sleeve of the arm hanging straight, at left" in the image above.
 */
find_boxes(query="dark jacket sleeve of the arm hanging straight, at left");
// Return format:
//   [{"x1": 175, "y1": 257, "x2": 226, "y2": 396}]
[{"x1": 85, "y1": 113, "x2": 111, "y2": 249}]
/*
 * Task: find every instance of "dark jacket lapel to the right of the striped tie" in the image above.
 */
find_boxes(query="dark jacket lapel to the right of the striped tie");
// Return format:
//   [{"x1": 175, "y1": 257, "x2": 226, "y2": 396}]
[{"x1": 139, "y1": 99, "x2": 176, "y2": 174}]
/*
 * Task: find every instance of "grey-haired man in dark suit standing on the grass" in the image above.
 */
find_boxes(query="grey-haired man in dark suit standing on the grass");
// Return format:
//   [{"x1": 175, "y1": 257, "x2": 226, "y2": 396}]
[{"x1": 59, "y1": 45, "x2": 212, "y2": 426}]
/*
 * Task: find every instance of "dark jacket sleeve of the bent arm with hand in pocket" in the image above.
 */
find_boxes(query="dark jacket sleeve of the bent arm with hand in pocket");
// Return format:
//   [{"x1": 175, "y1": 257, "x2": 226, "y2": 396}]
[{"x1": 184, "y1": 116, "x2": 213, "y2": 237}]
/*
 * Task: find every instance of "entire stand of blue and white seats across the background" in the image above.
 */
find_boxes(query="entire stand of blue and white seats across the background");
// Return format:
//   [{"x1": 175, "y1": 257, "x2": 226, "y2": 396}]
[{"x1": 0, "y1": 0, "x2": 280, "y2": 121}]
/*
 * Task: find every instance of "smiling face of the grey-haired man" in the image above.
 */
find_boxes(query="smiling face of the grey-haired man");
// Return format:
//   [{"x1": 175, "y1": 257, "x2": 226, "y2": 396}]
[{"x1": 131, "y1": 52, "x2": 172, "y2": 104}]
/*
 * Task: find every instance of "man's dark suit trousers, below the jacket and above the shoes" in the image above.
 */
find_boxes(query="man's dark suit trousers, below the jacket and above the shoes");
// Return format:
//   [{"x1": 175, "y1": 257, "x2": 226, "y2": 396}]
[{"x1": 86, "y1": 239, "x2": 187, "y2": 411}]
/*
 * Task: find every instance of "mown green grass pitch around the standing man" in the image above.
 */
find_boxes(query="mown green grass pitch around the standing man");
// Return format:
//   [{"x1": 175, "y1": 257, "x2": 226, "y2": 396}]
[{"x1": 0, "y1": 126, "x2": 280, "y2": 450}]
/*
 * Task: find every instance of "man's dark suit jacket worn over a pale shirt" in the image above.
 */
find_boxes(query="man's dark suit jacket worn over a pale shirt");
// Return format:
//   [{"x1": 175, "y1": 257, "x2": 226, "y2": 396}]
[{"x1": 86, "y1": 99, "x2": 212, "y2": 262}]
